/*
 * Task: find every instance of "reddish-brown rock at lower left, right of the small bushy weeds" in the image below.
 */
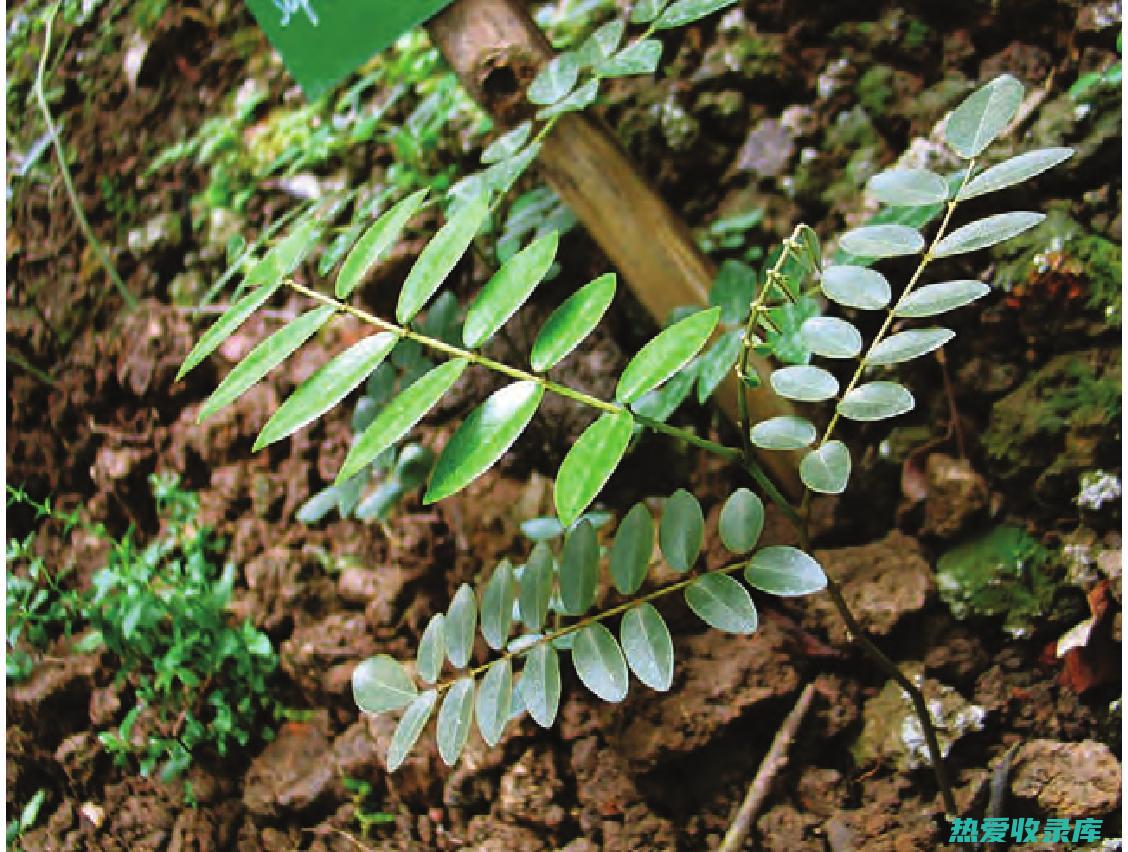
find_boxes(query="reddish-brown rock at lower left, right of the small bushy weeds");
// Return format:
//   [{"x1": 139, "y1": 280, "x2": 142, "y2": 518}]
[{"x1": 243, "y1": 722, "x2": 334, "y2": 818}]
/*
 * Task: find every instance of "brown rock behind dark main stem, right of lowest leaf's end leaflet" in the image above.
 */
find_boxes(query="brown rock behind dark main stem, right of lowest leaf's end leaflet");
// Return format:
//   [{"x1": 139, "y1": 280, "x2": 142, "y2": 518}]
[{"x1": 803, "y1": 530, "x2": 935, "y2": 643}]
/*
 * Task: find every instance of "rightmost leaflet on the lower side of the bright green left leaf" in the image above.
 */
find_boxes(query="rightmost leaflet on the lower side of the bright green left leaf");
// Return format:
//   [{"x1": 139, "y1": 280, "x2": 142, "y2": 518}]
[{"x1": 553, "y1": 412, "x2": 634, "y2": 526}]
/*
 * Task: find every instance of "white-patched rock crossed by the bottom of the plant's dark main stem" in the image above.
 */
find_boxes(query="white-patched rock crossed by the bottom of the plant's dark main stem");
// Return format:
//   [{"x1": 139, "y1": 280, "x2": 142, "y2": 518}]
[{"x1": 851, "y1": 664, "x2": 987, "y2": 771}]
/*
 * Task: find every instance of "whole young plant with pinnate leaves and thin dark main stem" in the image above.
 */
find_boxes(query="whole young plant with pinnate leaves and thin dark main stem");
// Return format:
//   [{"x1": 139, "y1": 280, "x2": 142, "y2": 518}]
[{"x1": 180, "y1": 38, "x2": 1070, "y2": 814}]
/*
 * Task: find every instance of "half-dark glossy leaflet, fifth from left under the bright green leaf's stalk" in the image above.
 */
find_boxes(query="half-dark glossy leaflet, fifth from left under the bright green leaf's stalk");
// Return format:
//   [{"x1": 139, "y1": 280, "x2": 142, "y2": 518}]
[{"x1": 423, "y1": 381, "x2": 545, "y2": 504}]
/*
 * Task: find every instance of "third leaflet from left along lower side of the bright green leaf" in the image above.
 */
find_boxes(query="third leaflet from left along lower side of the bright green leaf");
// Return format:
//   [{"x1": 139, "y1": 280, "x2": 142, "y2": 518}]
[{"x1": 253, "y1": 332, "x2": 399, "y2": 450}]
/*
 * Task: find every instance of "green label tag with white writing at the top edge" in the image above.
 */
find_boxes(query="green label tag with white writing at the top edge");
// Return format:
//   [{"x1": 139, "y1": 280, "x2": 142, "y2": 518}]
[{"x1": 247, "y1": 0, "x2": 452, "y2": 99}]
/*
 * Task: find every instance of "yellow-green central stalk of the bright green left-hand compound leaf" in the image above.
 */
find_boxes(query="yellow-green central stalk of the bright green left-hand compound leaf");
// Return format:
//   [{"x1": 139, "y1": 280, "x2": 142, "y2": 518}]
[{"x1": 287, "y1": 280, "x2": 740, "y2": 462}]
